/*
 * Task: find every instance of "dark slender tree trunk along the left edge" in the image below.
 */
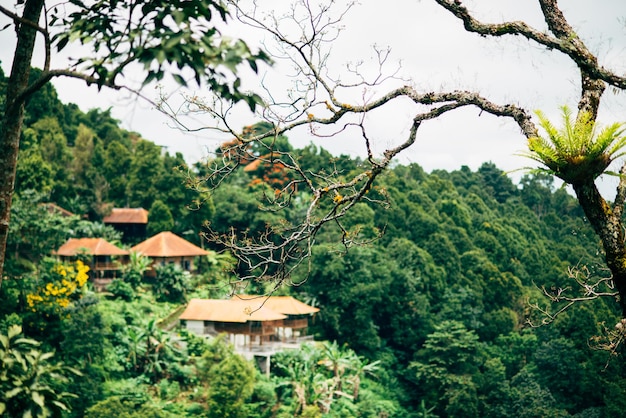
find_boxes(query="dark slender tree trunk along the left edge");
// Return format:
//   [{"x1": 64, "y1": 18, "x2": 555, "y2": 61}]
[{"x1": 0, "y1": 0, "x2": 44, "y2": 286}]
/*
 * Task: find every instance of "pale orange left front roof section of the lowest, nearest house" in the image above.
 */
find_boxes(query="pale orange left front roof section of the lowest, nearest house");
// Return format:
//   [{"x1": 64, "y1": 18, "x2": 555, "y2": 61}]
[{"x1": 179, "y1": 299, "x2": 287, "y2": 323}]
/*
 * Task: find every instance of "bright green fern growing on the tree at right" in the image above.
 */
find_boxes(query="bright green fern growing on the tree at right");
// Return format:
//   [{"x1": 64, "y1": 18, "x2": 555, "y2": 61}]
[{"x1": 525, "y1": 106, "x2": 626, "y2": 184}]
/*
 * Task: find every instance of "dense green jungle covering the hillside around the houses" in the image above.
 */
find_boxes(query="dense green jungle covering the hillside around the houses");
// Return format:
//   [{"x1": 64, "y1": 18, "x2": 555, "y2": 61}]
[{"x1": 0, "y1": 68, "x2": 626, "y2": 418}]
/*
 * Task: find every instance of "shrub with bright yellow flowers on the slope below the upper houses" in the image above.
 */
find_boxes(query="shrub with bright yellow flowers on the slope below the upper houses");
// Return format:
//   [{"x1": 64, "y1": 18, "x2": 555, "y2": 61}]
[{"x1": 26, "y1": 260, "x2": 89, "y2": 312}]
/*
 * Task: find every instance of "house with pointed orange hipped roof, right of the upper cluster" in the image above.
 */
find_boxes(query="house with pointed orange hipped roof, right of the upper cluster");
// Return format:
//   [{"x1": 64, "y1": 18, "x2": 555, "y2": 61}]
[{"x1": 130, "y1": 231, "x2": 209, "y2": 276}]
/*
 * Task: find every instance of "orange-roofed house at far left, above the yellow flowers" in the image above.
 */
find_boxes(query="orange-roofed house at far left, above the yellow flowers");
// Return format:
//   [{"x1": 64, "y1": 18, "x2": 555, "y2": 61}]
[{"x1": 54, "y1": 238, "x2": 129, "y2": 289}]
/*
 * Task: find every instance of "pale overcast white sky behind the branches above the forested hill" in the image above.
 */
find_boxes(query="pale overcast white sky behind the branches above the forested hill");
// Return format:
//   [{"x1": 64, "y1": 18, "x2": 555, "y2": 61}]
[{"x1": 0, "y1": 0, "x2": 626, "y2": 194}]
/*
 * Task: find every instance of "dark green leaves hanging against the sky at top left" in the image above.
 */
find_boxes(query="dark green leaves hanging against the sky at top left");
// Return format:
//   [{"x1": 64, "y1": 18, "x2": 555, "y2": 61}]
[{"x1": 51, "y1": 0, "x2": 270, "y2": 110}]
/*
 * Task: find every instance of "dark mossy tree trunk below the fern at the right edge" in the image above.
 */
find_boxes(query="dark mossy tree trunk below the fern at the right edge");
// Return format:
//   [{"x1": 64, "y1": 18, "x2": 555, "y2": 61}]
[{"x1": 572, "y1": 180, "x2": 626, "y2": 318}]
